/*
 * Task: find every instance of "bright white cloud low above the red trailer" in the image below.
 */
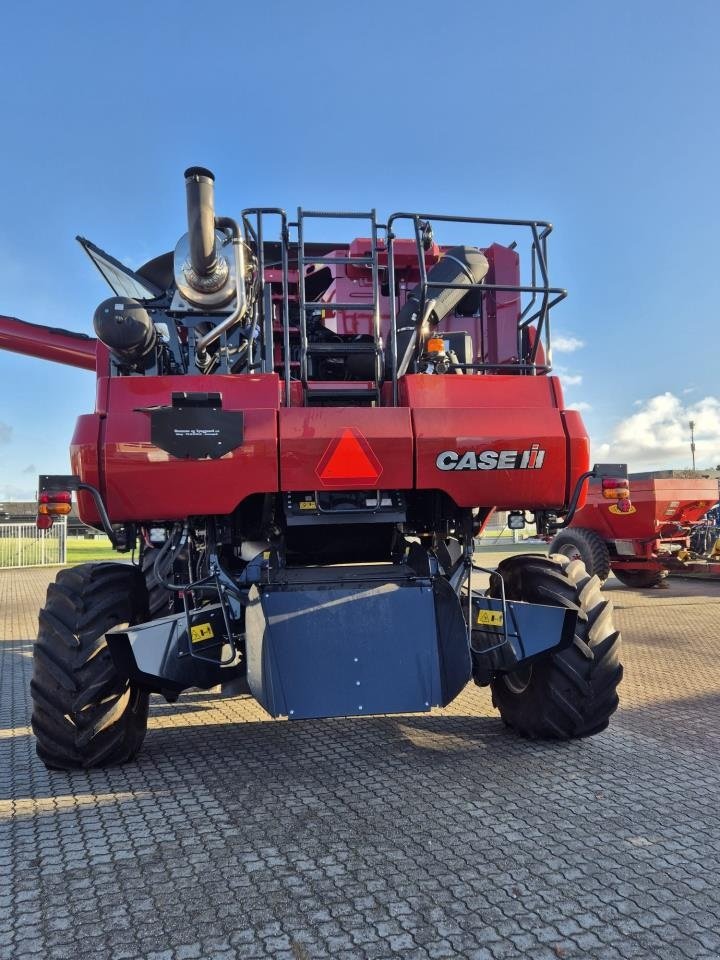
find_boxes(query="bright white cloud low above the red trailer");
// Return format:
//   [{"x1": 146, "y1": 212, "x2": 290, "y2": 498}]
[{"x1": 597, "y1": 393, "x2": 720, "y2": 469}]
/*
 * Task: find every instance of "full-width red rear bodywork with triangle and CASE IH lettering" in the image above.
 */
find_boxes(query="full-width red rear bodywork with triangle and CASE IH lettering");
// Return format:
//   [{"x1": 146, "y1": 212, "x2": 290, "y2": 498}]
[{"x1": 67, "y1": 374, "x2": 589, "y2": 522}]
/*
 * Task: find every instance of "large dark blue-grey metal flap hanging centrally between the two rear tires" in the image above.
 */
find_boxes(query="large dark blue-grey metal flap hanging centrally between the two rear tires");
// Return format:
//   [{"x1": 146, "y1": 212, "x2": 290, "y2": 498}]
[{"x1": 245, "y1": 567, "x2": 470, "y2": 720}]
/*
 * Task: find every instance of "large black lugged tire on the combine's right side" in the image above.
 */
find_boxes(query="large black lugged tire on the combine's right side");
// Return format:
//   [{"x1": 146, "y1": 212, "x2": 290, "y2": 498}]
[{"x1": 490, "y1": 555, "x2": 623, "y2": 740}]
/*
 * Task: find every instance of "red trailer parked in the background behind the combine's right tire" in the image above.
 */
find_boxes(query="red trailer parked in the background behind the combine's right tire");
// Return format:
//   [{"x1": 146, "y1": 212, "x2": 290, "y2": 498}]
[{"x1": 550, "y1": 470, "x2": 720, "y2": 587}]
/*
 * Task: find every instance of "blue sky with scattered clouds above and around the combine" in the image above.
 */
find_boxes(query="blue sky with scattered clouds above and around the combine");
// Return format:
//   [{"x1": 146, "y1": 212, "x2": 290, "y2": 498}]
[{"x1": 0, "y1": 0, "x2": 720, "y2": 499}]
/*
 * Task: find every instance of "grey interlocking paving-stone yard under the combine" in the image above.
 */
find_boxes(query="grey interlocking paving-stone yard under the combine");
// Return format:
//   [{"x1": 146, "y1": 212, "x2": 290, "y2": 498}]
[{"x1": 0, "y1": 558, "x2": 720, "y2": 960}]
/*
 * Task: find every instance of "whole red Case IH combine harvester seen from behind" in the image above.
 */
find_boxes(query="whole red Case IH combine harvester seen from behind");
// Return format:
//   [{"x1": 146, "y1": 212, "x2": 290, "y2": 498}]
[{"x1": 0, "y1": 168, "x2": 622, "y2": 768}]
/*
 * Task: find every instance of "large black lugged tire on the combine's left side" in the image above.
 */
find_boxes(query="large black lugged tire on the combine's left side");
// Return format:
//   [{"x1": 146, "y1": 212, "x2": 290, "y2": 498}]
[{"x1": 30, "y1": 563, "x2": 148, "y2": 770}]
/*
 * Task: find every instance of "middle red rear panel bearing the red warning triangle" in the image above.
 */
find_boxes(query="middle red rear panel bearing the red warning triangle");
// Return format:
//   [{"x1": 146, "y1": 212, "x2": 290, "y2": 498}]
[{"x1": 280, "y1": 407, "x2": 413, "y2": 490}]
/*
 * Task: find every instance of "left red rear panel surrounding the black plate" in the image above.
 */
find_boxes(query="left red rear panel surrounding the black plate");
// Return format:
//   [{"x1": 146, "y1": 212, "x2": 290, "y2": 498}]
[{"x1": 97, "y1": 374, "x2": 279, "y2": 521}]
